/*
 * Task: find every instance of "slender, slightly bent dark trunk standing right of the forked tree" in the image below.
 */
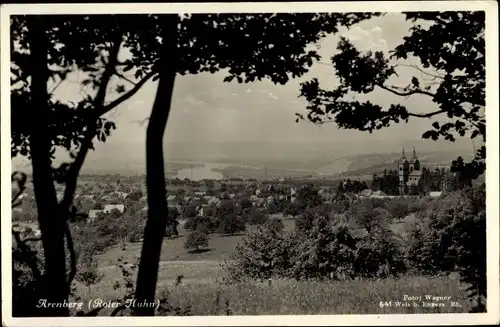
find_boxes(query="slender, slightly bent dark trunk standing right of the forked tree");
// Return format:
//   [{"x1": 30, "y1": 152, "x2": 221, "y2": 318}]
[{"x1": 135, "y1": 15, "x2": 179, "y2": 316}]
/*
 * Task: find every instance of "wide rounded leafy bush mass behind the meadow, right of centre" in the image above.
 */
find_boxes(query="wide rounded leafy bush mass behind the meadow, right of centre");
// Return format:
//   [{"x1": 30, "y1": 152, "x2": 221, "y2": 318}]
[{"x1": 225, "y1": 210, "x2": 405, "y2": 279}]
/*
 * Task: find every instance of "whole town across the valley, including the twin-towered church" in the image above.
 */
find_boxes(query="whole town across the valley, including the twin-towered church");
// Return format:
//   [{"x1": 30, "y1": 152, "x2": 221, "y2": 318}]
[{"x1": 13, "y1": 149, "x2": 458, "y2": 233}]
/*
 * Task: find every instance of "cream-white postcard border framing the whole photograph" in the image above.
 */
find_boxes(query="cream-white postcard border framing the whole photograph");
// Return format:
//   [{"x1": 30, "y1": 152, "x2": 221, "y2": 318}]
[{"x1": 0, "y1": 1, "x2": 500, "y2": 326}]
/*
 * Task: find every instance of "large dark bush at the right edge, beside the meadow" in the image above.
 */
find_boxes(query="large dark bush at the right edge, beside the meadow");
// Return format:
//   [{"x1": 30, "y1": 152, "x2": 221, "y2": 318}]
[{"x1": 407, "y1": 184, "x2": 486, "y2": 312}]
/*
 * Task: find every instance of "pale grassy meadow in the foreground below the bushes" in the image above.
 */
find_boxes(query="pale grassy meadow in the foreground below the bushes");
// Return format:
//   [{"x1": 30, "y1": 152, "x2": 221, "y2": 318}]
[{"x1": 77, "y1": 217, "x2": 470, "y2": 315}]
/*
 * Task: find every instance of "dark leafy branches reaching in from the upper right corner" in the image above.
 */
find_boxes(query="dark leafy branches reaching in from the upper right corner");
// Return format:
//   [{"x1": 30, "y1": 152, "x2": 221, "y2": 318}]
[{"x1": 297, "y1": 11, "x2": 486, "y2": 178}]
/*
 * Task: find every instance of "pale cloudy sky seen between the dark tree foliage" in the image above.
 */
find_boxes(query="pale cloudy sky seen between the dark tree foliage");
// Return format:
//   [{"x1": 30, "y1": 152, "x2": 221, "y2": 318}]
[{"x1": 14, "y1": 13, "x2": 471, "y2": 169}]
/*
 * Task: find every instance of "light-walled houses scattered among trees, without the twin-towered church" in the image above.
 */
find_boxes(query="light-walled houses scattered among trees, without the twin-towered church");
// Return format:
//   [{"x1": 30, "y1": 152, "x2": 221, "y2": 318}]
[{"x1": 13, "y1": 176, "x2": 441, "y2": 237}]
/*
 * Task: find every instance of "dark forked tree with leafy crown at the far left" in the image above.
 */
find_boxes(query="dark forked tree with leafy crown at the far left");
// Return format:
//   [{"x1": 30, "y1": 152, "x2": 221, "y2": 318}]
[{"x1": 11, "y1": 15, "x2": 158, "y2": 316}]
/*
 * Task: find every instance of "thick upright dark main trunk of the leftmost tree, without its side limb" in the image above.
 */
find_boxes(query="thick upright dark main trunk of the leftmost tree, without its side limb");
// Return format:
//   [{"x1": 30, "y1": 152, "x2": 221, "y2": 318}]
[{"x1": 28, "y1": 16, "x2": 69, "y2": 316}]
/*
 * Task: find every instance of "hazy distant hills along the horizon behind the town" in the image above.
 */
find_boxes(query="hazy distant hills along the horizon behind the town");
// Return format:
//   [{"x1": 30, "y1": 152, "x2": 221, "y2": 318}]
[{"x1": 12, "y1": 140, "x2": 472, "y2": 176}]
